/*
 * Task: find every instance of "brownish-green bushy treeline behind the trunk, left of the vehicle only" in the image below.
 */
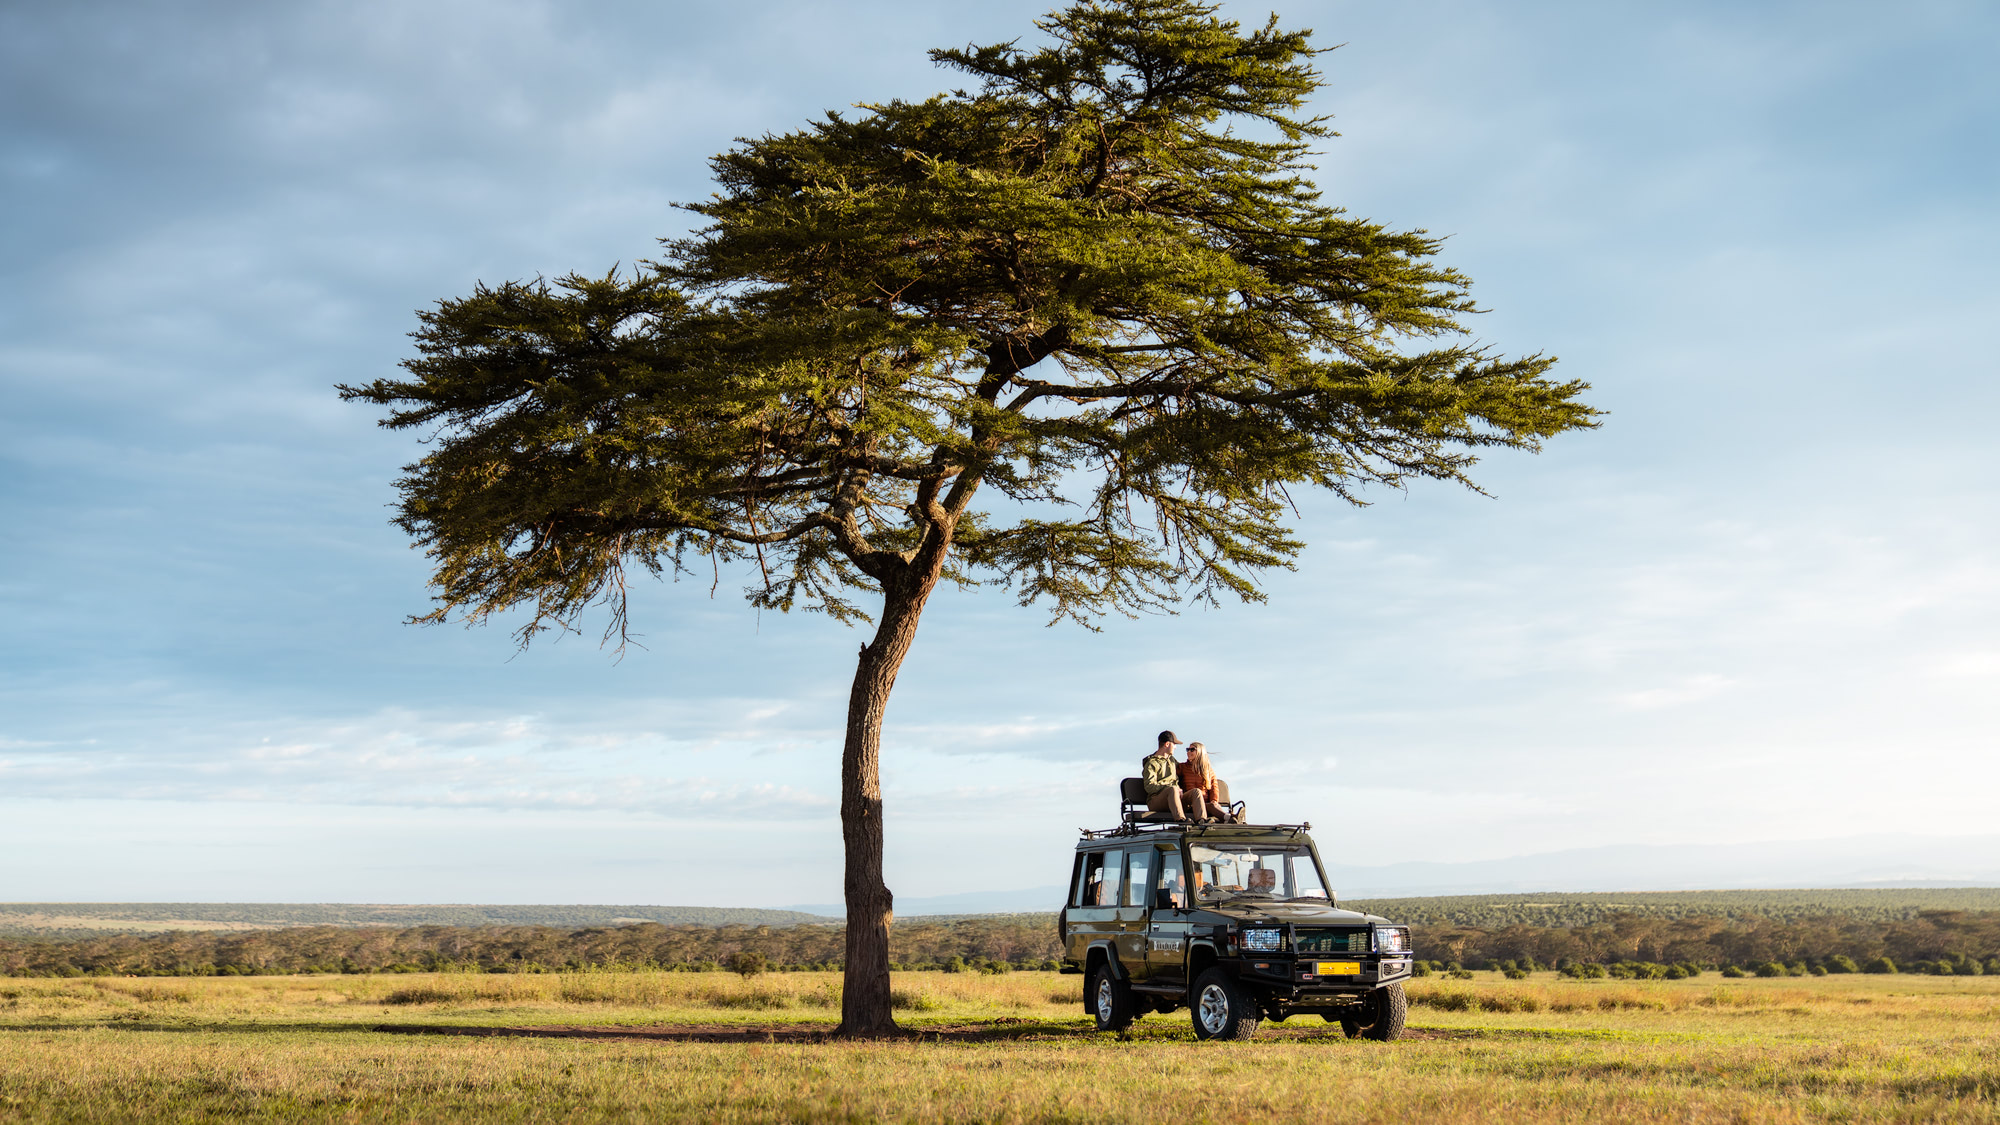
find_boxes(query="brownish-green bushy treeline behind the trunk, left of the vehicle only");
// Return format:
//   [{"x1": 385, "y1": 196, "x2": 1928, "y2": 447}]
[{"x1": 0, "y1": 915, "x2": 1060, "y2": 977}]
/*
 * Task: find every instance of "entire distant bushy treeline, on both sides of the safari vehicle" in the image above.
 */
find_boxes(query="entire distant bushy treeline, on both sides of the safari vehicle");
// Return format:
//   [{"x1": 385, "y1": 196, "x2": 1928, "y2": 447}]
[{"x1": 15, "y1": 891, "x2": 2000, "y2": 975}]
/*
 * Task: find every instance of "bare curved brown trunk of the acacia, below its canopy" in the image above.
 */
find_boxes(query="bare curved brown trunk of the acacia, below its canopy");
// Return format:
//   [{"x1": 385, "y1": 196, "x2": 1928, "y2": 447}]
[{"x1": 836, "y1": 569, "x2": 938, "y2": 1035}]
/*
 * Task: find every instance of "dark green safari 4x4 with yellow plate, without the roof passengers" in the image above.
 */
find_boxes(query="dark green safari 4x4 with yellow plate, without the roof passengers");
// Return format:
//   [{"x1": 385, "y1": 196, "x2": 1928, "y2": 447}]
[{"x1": 1056, "y1": 823, "x2": 1410, "y2": 1039}]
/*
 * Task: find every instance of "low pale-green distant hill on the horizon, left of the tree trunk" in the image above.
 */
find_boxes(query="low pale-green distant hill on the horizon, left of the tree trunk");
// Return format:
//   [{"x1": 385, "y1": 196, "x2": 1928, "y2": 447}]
[{"x1": 0, "y1": 903, "x2": 826, "y2": 937}]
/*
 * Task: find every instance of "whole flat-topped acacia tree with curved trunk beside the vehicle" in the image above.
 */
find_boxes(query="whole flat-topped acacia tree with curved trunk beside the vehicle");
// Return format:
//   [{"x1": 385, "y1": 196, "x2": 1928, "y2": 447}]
[{"x1": 342, "y1": 0, "x2": 1596, "y2": 1035}]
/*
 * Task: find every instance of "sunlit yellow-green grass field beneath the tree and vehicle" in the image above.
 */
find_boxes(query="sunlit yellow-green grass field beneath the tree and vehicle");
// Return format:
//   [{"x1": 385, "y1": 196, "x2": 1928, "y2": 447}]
[{"x1": 0, "y1": 973, "x2": 2000, "y2": 1123}]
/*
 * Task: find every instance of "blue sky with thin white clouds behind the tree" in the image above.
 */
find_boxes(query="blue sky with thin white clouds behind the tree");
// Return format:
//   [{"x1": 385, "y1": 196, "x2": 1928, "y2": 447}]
[{"x1": 0, "y1": 0, "x2": 2000, "y2": 905}]
